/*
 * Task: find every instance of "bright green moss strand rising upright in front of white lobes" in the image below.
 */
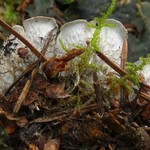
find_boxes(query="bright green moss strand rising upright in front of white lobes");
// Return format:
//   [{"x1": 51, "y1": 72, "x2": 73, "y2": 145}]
[{"x1": 78, "y1": 0, "x2": 116, "y2": 72}]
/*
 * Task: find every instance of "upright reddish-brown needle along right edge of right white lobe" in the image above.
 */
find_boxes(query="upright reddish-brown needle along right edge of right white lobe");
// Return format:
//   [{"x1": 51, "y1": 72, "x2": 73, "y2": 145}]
[{"x1": 120, "y1": 40, "x2": 128, "y2": 105}]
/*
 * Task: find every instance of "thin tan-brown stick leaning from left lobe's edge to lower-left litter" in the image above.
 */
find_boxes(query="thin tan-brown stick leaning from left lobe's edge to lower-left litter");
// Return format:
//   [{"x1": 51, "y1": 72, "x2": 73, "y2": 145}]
[{"x1": 13, "y1": 29, "x2": 55, "y2": 113}]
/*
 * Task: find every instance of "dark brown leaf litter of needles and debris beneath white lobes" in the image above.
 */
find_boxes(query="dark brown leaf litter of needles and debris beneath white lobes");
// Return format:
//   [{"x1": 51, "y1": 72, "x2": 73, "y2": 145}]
[{"x1": 0, "y1": 0, "x2": 150, "y2": 150}]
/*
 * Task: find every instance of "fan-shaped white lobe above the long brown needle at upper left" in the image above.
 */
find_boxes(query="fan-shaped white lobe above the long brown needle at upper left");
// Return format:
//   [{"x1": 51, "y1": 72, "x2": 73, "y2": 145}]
[{"x1": 23, "y1": 16, "x2": 58, "y2": 57}]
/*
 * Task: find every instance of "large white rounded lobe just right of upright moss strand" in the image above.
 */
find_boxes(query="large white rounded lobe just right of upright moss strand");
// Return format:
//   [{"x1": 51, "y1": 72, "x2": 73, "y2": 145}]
[{"x1": 99, "y1": 19, "x2": 127, "y2": 64}]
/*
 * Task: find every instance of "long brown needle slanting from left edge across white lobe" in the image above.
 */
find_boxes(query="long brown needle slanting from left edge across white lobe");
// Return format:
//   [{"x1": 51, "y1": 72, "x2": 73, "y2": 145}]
[{"x1": 0, "y1": 19, "x2": 47, "y2": 61}]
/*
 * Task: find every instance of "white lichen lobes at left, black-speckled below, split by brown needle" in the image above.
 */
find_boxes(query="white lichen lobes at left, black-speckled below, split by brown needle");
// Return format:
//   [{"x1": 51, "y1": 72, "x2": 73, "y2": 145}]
[{"x1": 0, "y1": 16, "x2": 58, "y2": 93}]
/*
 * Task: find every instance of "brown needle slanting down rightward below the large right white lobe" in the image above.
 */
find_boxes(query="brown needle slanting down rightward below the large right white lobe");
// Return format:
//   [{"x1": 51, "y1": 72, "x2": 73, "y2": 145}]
[{"x1": 96, "y1": 52, "x2": 150, "y2": 101}]
